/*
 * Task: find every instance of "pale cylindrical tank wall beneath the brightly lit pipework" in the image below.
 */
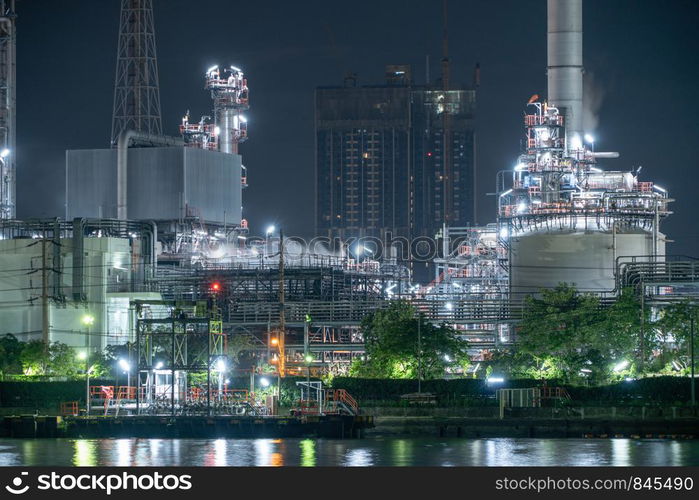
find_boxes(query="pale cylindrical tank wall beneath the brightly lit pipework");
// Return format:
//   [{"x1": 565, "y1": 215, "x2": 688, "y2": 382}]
[{"x1": 510, "y1": 229, "x2": 665, "y2": 300}]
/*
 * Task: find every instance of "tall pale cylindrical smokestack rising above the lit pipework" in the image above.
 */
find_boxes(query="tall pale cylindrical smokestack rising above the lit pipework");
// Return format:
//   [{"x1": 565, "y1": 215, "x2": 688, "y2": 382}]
[{"x1": 547, "y1": 0, "x2": 583, "y2": 142}]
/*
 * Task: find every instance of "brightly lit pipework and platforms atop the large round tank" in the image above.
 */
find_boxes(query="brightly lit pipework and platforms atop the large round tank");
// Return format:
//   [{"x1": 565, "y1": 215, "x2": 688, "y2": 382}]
[{"x1": 497, "y1": 102, "x2": 672, "y2": 239}]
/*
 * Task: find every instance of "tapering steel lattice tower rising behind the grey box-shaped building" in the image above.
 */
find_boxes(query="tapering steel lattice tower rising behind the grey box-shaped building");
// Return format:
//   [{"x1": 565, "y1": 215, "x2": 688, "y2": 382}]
[{"x1": 111, "y1": 0, "x2": 162, "y2": 146}]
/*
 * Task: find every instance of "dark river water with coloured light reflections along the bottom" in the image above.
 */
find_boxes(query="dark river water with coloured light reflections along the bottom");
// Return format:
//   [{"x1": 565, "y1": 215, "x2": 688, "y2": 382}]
[{"x1": 0, "y1": 438, "x2": 699, "y2": 467}]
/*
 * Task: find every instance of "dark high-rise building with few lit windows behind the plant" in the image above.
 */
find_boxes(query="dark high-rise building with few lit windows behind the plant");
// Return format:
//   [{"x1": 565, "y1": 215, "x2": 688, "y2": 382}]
[{"x1": 315, "y1": 66, "x2": 476, "y2": 248}]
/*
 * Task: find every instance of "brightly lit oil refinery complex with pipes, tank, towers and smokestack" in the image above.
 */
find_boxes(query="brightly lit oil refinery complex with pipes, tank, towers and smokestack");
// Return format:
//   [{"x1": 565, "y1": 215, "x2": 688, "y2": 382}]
[{"x1": 0, "y1": 0, "x2": 699, "y2": 414}]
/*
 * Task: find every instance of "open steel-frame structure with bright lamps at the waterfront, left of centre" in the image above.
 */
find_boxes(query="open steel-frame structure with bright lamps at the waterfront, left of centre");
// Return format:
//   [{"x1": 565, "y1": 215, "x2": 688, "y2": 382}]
[{"x1": 133, "y1": 301, "x2": 267, "y2": 416}]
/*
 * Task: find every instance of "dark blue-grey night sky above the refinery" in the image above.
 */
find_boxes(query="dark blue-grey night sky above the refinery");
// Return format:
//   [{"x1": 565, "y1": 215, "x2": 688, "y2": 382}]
[{"x1": 17, "y1": 0, "x2": 699, "y2": 256}]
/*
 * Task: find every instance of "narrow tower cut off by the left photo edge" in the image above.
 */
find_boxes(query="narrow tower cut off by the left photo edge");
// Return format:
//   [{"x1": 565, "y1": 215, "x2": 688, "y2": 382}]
[{"x1": 0, "y1": 0, "x2": 16, "y2": 219}]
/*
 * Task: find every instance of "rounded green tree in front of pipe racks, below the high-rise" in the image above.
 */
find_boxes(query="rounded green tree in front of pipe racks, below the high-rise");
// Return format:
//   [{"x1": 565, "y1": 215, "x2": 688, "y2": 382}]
[{"x1": 351, "y1": 301, "x2": 466, "y2": 379}]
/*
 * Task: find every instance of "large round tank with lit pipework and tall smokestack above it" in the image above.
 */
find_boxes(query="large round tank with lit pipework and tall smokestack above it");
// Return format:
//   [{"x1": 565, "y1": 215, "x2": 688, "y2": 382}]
[{"x1": 498, "y1": 0, "x2": 671, "y2": 300}]
